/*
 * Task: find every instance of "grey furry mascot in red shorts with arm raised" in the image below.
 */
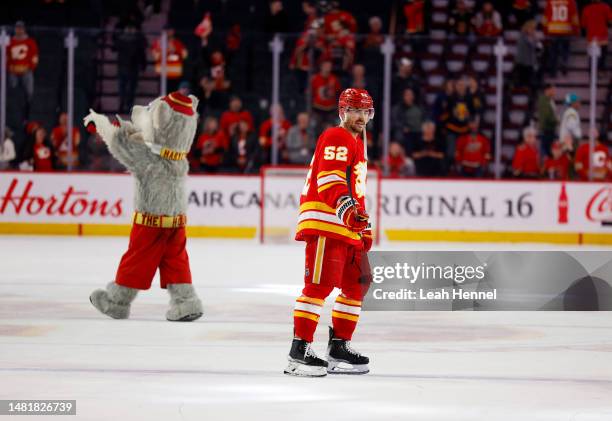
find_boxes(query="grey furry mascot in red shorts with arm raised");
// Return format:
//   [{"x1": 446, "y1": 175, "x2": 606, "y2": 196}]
[{"x1": 84, "y1": 92, "x2": 202, "y2": 321}]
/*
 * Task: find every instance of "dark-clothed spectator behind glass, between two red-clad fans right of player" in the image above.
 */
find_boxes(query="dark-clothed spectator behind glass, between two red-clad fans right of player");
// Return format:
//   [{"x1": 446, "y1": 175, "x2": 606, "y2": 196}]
[{"x1": 412, "y1": 121, "x2": 445, "y2": 177}]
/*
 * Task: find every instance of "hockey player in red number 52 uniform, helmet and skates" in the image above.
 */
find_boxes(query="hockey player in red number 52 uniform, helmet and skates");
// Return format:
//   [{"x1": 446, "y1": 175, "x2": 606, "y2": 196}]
[{"x1": 285, "y1": 88, "x2": 374, "y2": 377}]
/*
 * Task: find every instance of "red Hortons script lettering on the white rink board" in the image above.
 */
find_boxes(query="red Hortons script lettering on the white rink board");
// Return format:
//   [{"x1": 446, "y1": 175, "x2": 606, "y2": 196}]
[{"x1": 0, "y1": 178, "x2": 123, "y2": 218}]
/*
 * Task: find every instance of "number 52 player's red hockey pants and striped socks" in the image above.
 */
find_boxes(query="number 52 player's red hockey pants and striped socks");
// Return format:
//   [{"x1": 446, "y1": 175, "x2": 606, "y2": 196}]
[{"x1": 293, "y1": 237, "x2": 371, "y2": 342}]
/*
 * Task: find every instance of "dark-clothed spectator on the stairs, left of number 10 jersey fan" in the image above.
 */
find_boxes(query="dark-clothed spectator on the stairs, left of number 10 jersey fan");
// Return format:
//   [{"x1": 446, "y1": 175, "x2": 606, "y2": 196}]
[{"x1": 514, "y1": 20, "x2": 538, "y2": 91}]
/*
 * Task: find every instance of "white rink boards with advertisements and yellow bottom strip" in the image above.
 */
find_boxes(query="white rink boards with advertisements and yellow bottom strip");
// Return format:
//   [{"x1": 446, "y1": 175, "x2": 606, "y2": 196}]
[{"x1": 0, "y1": 172, "x2": 612, "y2": 245}]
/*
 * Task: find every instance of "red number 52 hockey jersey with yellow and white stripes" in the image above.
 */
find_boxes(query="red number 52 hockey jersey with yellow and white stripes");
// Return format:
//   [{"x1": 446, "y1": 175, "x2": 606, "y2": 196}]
[{"x1": 295, "y1": 127, "x2": 372, "y2": 245}]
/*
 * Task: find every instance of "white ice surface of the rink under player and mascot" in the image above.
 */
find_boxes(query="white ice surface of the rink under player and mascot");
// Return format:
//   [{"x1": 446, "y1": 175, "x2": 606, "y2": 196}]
[{"x1": 0, "y1": 237, "x2": 612, "y2": 421}]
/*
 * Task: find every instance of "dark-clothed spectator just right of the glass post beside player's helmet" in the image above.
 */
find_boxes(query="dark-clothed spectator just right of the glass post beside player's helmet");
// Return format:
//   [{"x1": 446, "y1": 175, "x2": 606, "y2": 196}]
[{"x1": 391, "y1": 88, "x2": 424, "y2": 151}]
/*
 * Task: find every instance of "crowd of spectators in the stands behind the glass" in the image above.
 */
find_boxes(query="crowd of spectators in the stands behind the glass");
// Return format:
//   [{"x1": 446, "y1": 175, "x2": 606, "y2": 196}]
[{"x1": 0, "y1": 0, "x2": 612, "y2": 180}]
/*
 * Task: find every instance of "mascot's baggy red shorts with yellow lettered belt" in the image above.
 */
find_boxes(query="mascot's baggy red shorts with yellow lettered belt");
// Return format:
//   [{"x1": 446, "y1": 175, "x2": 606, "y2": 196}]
[{"x1": 115, "y1": 212, "x2": 191, "y2": 290}]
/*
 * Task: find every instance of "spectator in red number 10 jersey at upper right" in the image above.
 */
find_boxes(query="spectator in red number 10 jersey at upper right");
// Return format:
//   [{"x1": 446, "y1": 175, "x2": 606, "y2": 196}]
[{"x1": 542, "y1": 0, "x2": 580, "y2": 77}]
